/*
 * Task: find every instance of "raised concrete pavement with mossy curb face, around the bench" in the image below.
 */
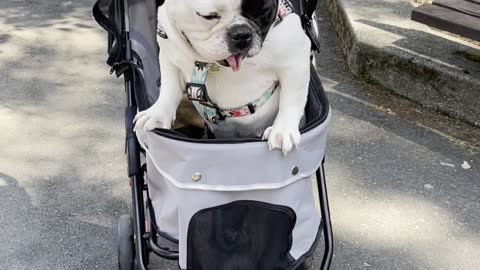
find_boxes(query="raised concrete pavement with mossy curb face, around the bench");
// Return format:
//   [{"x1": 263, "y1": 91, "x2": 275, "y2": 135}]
[{"x1": 322, "y1": 0, "x2": 480, "y2": 127}]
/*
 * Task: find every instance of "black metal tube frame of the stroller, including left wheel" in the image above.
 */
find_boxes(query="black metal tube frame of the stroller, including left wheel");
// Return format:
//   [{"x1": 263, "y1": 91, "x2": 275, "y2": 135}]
[{"x1": 93, "y1": 0, "x2": 333, "y2": 270}]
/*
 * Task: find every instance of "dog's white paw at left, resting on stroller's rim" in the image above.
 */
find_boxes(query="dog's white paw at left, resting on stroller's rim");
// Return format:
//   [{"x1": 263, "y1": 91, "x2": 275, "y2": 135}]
[{"x1": 133, "y1": 107, "x2": 175, "y2": 131}]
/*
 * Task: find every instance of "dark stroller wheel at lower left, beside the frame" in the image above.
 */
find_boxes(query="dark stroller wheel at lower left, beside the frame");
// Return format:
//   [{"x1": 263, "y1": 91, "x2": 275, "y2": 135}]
[{"x1": 117, "y1": 215, "x2": 135, "y2": 270}]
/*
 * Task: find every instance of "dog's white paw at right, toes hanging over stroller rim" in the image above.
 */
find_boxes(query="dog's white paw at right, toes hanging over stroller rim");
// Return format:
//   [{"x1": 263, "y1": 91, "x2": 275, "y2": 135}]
[{"x1": 263, "y1": 124, "x2": 300, "y2": 156}]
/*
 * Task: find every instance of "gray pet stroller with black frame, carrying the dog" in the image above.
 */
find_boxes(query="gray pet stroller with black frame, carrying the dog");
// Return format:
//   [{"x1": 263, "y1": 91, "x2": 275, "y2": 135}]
[{"x1": 93, "y1": 0, "x2": 333, "y2": 270}]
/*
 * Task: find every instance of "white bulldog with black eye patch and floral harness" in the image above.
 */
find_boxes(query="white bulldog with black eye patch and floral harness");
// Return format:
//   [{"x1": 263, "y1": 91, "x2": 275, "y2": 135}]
[{"x1": 134, "y1": 0, "x2": 311, "y2": 155}]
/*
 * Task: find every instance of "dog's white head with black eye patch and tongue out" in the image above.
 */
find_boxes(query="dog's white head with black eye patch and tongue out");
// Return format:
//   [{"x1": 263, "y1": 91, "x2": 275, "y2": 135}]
[{"x1": 166, "y1": 0, "x2": 278, "y2": 71}]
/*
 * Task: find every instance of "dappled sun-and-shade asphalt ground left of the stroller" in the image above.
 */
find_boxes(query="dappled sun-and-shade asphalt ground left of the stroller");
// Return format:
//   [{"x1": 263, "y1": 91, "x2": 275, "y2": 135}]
[{"x1": 0, "y1": 0, "x2": 130, "y2": 270}]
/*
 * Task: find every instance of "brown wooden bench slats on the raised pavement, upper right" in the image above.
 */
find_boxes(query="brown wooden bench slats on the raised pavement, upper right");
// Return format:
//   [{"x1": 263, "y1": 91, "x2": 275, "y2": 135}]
[{"x1": 412, "y1": 0, "x2": 480, "y2": 41}]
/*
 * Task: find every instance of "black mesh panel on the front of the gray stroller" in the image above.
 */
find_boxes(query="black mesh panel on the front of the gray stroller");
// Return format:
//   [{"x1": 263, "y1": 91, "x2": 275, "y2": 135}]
[{"x1": 187, "y1": 201, "x2": 296, "y2": 270}]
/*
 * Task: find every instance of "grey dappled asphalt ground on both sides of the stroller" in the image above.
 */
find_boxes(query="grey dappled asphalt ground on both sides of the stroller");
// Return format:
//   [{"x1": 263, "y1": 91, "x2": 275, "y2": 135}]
[{"x1": 0, "y1": 0, "x2": 480, "y2": 270}]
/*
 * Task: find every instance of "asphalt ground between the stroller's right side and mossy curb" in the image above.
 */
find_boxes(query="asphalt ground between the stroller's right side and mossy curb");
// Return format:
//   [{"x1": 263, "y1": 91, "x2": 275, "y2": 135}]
[{"x1": 318, "y1": 1, "x2": 480, "y2": 270}]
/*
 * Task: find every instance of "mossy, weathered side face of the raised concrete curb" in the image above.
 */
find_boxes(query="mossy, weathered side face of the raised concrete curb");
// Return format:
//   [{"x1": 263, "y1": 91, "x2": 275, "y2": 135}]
[{"x1": 326, "y1": 0, "x2": 480, "y2": 127}]
